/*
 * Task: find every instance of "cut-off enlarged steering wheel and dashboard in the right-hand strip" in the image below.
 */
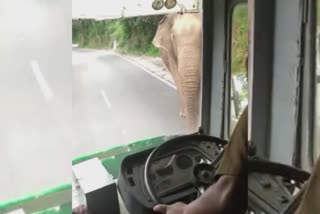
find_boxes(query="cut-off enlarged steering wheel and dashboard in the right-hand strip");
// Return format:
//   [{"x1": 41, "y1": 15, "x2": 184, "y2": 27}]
[{"x1": 248, "y1": 157, "x2": 310, "y2": 214}]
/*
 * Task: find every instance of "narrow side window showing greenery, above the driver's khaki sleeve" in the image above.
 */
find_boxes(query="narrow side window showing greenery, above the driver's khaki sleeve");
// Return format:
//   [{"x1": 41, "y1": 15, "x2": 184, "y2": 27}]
[{"x1": 229, "y1": 4, "x2": 248, "y2": 135}]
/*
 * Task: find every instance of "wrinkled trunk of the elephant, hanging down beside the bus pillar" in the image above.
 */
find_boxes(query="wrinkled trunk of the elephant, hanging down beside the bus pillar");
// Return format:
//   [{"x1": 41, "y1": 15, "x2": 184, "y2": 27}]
[{"x1": 178, "y1": 46, "x2": 200, "y2": 131}]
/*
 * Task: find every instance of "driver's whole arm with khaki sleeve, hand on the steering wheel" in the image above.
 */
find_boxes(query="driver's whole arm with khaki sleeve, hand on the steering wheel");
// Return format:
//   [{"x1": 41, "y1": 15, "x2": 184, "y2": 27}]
[{"x1": 154, "y1": 109, "x2": 248, "y2": 214}]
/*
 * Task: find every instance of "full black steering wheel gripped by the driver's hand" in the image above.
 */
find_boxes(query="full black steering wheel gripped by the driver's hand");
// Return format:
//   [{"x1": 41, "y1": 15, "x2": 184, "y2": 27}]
[{"x1": 144, "y1": 134, "x2": 227, "y2": 204}]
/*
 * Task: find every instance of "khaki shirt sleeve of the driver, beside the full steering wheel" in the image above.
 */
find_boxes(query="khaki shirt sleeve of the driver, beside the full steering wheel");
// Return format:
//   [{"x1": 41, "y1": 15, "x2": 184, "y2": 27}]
[{"x1": 216, "y1": 108, "x2": 248, "y2": 176}]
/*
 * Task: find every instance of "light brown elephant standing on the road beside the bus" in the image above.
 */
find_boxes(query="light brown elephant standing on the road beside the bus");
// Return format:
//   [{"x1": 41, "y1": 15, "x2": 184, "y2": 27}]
[{"x1": 152, "y1": 13, "x2": 202, "y2": 131}]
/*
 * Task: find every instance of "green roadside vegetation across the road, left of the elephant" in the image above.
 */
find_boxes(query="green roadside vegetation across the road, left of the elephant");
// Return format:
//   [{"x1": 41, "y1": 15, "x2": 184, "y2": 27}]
[{"x1": 72, "y1": 16, "x2": 162, "y2": 56}]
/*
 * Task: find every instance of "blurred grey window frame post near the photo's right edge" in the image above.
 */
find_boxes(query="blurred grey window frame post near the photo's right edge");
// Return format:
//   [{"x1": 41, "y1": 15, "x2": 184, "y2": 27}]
[{"x1": 297, "y1": 0, "x2": 319, "y2": 169}]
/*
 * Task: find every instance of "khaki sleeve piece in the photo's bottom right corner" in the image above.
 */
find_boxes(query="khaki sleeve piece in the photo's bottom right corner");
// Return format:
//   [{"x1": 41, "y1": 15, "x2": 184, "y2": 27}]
[{"x1": 296, "y1": 157, "x2": 320, "y2": 214}]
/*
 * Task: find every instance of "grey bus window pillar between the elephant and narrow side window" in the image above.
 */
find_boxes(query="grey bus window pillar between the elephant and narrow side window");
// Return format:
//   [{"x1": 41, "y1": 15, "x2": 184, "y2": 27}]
[{"x1": 201, "y1": 0, "x2": 247, "y2": 139}]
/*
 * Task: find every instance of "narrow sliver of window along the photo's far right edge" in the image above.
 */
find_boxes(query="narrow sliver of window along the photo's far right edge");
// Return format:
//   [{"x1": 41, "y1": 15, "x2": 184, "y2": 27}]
[{"x1": 314, "y1": 0, "x2": 320, "y2": 157}]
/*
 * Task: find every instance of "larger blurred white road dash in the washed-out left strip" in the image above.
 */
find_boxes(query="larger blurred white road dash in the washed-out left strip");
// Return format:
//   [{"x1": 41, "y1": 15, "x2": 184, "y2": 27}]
[{"x1": 31, "y1": 60, "x2": 53, "y2": 102}]
